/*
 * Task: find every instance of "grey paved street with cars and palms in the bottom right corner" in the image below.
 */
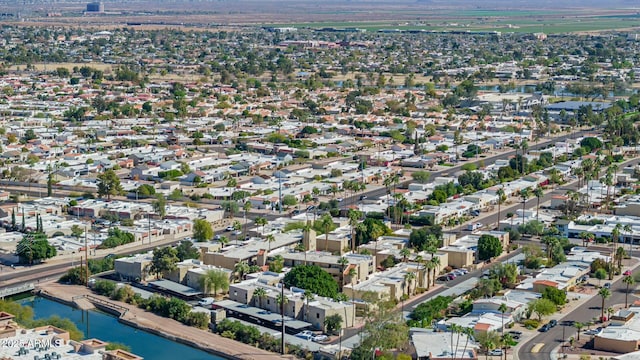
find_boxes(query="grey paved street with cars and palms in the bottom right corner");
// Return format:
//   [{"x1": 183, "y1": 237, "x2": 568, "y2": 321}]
[{"x1": 518, "y1": 271, "x2": 640, "y2": 360}]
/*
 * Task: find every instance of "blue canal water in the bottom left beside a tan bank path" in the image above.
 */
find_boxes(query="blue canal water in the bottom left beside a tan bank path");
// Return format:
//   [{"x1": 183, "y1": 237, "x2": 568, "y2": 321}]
[{"x1": 21, "y1": 297, "x2": 223, "y2": 360}]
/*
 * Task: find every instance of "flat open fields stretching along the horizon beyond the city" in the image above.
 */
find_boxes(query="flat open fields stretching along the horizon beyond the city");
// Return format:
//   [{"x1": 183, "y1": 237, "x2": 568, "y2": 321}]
[{"x1": 0, "y1": 0, "x2": 640, "y2": 34}]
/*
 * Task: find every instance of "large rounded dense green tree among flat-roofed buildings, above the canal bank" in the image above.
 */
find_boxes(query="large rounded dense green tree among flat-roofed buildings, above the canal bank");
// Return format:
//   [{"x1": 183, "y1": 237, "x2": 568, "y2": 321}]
[{"x1": 284, "y1": 265, "x2": 338, "y2": 298}]
